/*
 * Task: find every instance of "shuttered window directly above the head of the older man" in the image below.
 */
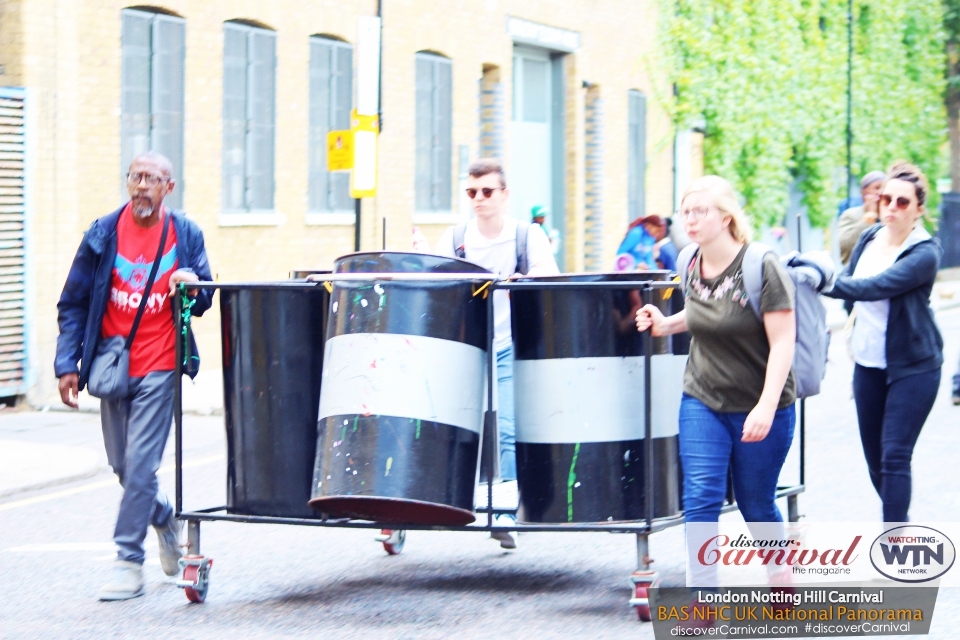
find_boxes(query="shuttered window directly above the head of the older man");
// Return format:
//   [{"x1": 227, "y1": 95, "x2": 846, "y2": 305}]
[{"x1": 120, "y1": 9, "x2": 186, "y2": 208}]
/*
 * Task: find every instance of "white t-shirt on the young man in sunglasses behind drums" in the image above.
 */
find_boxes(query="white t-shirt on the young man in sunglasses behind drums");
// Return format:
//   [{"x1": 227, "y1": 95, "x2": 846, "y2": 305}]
[{"x1": 434, "y1": 216, "x2": 556, "y2": 351}]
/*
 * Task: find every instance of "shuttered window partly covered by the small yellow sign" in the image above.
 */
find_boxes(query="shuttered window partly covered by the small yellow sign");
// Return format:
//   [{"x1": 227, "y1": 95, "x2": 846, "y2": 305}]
[{"x1": 308, "y1": 36, "x2": 353, "y2": 213}]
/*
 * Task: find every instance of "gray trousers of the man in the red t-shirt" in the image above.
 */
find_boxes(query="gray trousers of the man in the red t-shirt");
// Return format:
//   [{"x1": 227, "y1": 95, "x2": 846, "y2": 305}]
[{"x1": 100, "y1": 371, "x2": 174, "y2": 564}]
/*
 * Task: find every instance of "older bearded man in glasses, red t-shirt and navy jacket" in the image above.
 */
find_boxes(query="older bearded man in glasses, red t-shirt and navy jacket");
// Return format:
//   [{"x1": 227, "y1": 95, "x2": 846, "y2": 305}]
[{"x1": 54, "y1": 151, "x2": 213, "y2": 600}]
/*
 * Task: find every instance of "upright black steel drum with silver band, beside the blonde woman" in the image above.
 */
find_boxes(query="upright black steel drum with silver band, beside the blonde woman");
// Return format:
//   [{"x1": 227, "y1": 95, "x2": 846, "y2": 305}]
[{"x1": 510, "y1": 271, "x2": 687, "y2": 523}]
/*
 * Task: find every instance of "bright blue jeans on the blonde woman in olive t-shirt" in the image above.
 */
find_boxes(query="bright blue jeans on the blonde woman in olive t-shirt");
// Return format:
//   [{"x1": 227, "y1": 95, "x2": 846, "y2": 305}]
[{"x1": 680, "y1": 394, "x2": 797, "y2": 522}]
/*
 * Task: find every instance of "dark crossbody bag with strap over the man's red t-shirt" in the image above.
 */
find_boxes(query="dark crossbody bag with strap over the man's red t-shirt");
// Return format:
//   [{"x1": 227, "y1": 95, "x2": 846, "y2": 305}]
[{"x1": 87, "y1": 216, "x2": 173, "y2": 400}]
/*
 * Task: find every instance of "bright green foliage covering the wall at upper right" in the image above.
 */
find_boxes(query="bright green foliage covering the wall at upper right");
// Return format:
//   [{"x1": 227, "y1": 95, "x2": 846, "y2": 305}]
[{"x1": 656, "y1": 0, "x2": 946, "y2": 226}]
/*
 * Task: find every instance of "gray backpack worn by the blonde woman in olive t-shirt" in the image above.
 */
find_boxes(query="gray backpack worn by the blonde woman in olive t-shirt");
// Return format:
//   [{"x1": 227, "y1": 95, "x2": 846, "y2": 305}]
[{"x1": 677, "y1": 242, "x2": 834, "y2": 398}]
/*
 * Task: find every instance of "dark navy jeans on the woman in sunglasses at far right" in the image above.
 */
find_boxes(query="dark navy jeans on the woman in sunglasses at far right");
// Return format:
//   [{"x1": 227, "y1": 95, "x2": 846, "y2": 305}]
[{"x1": 853, "y1": 365, "x2": 940, "y2": 522}]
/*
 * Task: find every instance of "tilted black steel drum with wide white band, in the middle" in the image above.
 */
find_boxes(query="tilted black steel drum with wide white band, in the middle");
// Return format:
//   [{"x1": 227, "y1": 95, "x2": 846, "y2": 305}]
[{"x1": 310, "y1": 252, "x2": 490, "y2": 525}]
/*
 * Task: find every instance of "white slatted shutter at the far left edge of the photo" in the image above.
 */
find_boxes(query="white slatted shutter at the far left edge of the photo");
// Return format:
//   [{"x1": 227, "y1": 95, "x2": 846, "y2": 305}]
[{"x1": 0, "y1": 87, "x2": 32, "y2": 397}]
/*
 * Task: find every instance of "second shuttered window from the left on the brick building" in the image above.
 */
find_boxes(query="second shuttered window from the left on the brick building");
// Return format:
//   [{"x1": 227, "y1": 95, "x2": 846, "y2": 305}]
[{"x1": 222, "y1": 22, "x2": 277, "y2": 213}]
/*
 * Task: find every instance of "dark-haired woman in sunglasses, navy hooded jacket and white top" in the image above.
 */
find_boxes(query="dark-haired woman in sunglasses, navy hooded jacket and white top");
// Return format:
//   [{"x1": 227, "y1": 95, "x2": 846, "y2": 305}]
[{"x1": 824, "y1": 162, "x2": 943, "y2": 522}]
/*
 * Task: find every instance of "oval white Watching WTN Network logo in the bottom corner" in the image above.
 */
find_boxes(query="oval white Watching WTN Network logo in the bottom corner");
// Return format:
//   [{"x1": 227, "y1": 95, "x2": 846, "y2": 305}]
[{"x1": 870, "y1": 525, "x2": 957, "y2": 582}]
